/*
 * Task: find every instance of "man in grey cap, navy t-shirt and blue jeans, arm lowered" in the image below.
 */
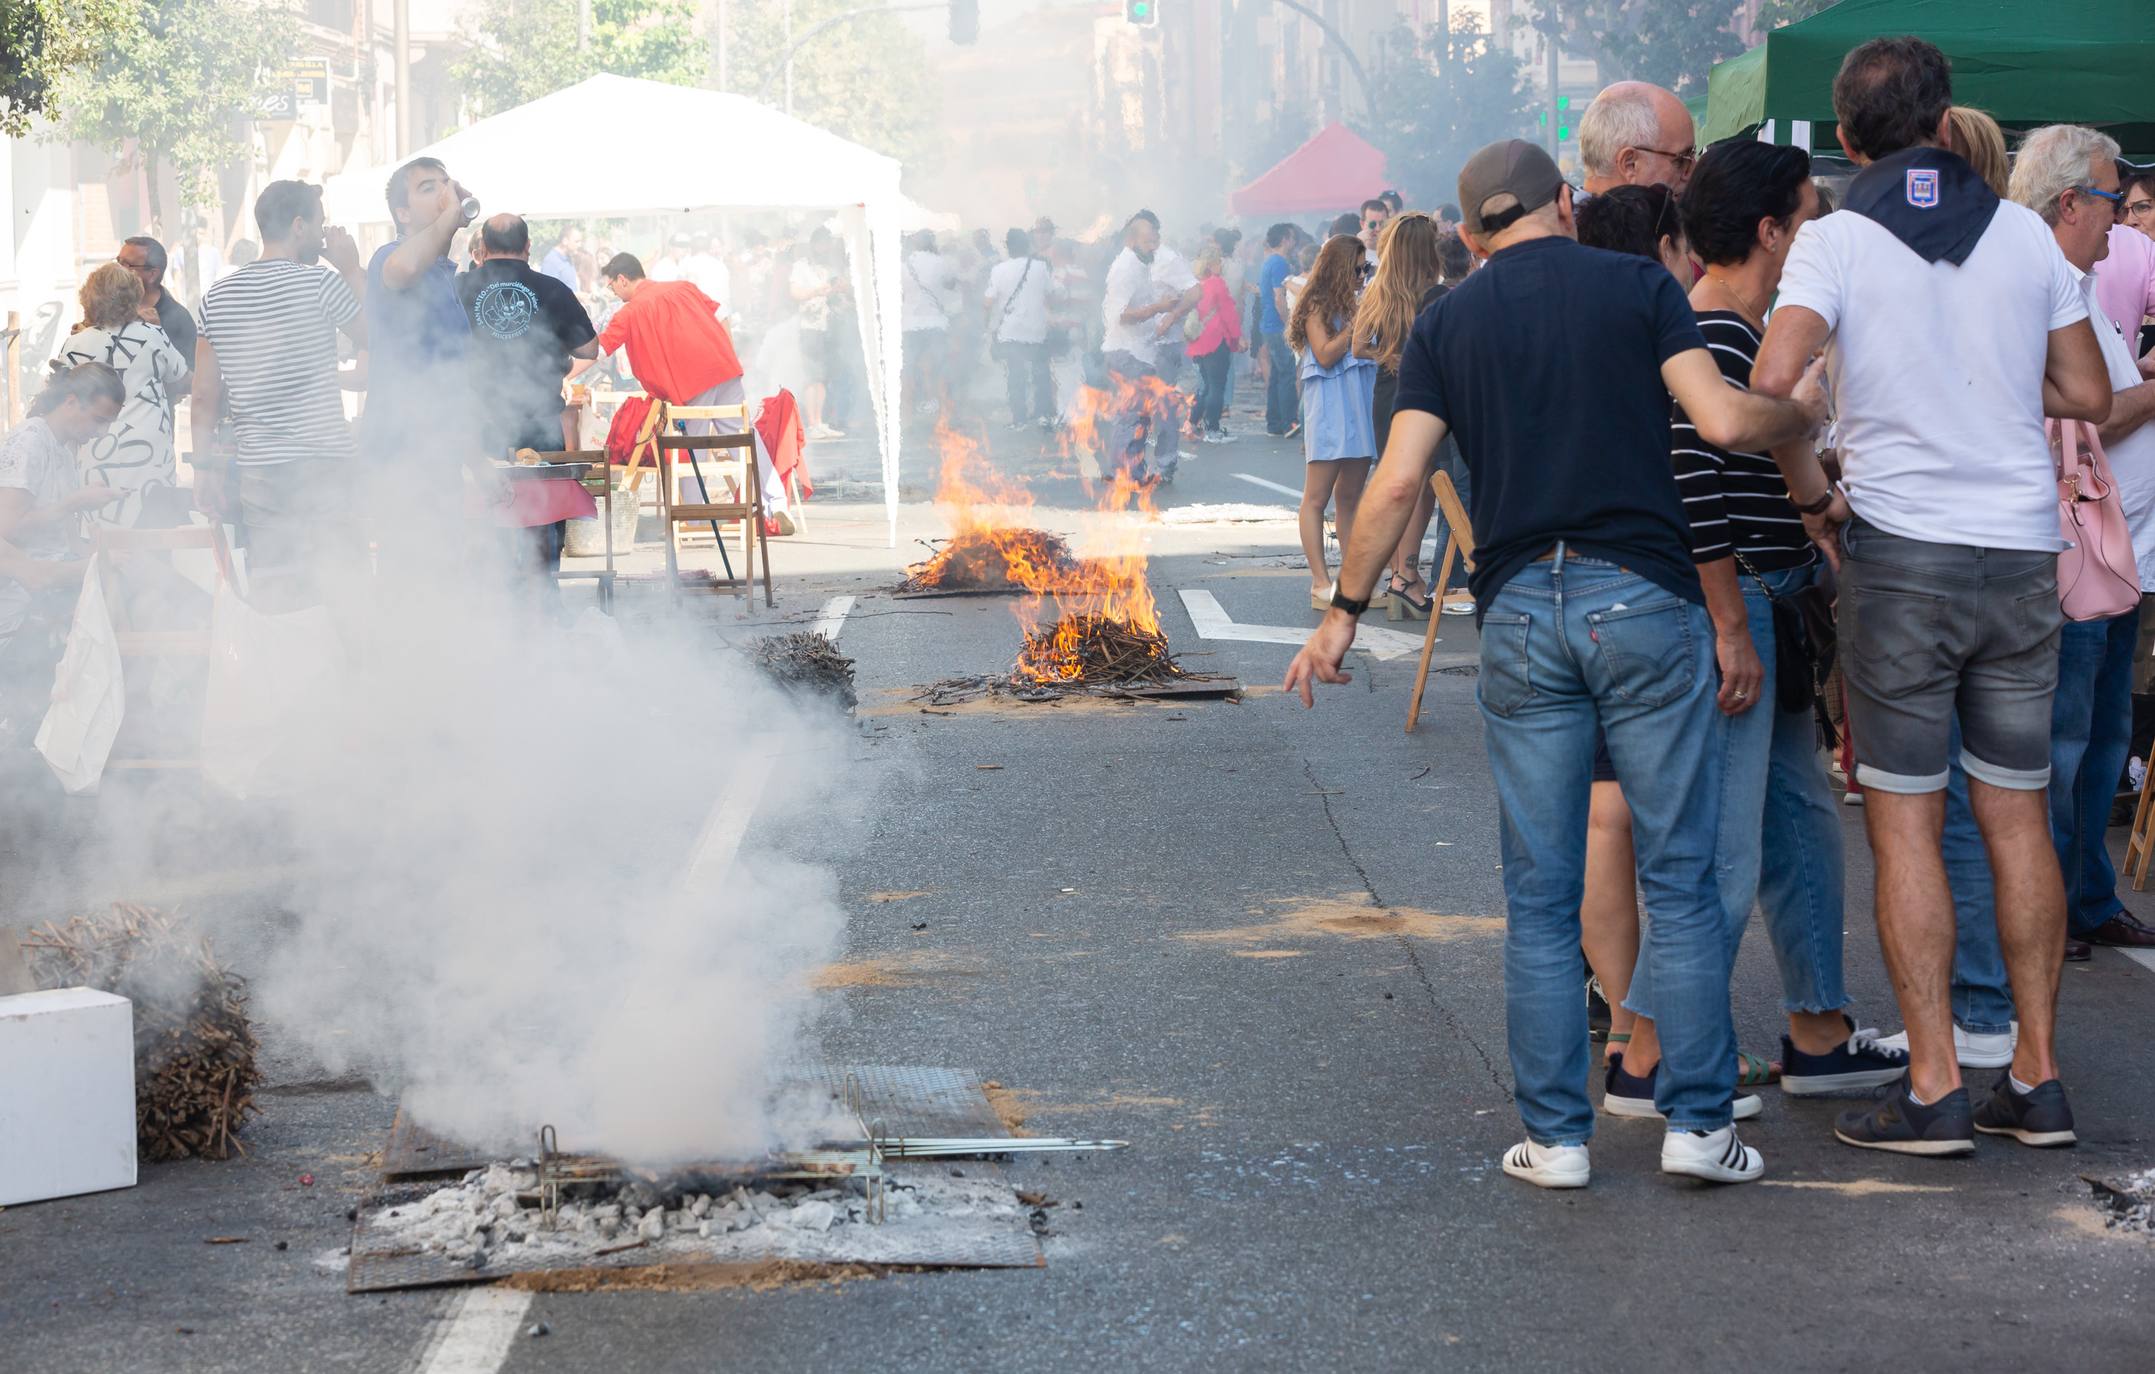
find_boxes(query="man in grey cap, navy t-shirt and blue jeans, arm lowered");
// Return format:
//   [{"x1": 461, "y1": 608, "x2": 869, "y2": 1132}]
[{"x1": 1287, "y1": 140, "x2": 1825, "y2": 1189}]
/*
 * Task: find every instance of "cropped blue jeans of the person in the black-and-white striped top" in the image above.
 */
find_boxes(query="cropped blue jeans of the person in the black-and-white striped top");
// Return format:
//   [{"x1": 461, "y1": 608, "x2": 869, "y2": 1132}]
[{"x1": 1625, "y1": 564, "x2": 1853, "y2": 1021}]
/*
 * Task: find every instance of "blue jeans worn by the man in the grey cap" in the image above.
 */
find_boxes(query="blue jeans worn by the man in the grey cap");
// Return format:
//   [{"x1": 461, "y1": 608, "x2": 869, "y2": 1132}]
[{"x1": 1476, "y1": 543, "x2": 1737, "y2": 1146}]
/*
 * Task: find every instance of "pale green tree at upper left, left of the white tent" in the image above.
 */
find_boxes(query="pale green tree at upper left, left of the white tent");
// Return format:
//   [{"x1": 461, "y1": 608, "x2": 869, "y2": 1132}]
[{"x1": 52, "y1": 0, "x2": 293, "y2": 218}]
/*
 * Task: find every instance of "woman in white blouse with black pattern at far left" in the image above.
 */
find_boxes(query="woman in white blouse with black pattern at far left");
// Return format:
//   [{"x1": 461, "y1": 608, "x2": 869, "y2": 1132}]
[{"x1": 60, "y1": 263, "x2": 190, "y2": 525}]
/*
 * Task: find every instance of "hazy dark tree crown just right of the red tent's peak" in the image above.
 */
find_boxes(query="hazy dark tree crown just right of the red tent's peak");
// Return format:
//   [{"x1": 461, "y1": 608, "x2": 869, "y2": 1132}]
[{"x1": 1362, "y1": 13, "x2": 1537, "y2": 205}]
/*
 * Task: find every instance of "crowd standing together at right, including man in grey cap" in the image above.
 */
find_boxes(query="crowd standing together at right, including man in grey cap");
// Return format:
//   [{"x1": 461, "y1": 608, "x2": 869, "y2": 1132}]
[{"x1": 1265, "y1": 39, "x2": 2155, "y2": 1187}]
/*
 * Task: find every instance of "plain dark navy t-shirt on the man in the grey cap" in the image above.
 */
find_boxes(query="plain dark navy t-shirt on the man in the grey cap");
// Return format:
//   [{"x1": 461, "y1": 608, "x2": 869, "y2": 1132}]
[{"x1": 1399, "y1": 237, "x2": 1707, "y2": 607}]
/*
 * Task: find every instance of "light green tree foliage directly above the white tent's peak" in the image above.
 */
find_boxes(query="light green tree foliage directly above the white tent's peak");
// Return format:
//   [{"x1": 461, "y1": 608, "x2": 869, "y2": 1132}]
[{"x1": 453, "y1": 0, "x2": 709, "y2": 116}]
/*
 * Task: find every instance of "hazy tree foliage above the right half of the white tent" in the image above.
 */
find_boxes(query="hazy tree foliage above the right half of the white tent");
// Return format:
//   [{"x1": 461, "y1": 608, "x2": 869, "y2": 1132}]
[{"x1": 726, "y1": 0, "x2": 942, "y2": 166}]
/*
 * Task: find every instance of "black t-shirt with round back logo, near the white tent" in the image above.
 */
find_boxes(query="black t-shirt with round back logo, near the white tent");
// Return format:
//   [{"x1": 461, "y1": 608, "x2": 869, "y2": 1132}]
[{"x1": 457, "y1": 258, "x2": 597, "y2": 459}]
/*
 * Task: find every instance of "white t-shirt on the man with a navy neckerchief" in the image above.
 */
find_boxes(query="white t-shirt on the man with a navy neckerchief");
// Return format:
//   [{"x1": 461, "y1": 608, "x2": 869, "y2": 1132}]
[{"x1": 1778, "y1": 202, "x2": 2088, "y2": 551}]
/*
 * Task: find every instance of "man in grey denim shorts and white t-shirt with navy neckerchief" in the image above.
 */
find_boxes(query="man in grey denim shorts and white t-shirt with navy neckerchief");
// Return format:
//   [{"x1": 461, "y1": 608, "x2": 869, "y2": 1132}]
[{"x1": 1752, "y1": 39, "x2": 2110, "y2": 1154}]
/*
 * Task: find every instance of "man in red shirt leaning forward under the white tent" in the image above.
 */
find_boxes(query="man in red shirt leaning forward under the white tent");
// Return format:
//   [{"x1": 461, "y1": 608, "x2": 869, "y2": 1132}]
[{"x1": 599, "y1": 252, "x2": 793, "y2": 534}]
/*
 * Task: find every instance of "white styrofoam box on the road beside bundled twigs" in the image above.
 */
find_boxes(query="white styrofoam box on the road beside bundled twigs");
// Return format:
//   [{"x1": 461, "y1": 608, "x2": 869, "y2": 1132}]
[{"x1": 0, "y1": 989, "x2": 136, "y2": 1206}]
